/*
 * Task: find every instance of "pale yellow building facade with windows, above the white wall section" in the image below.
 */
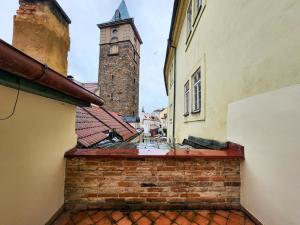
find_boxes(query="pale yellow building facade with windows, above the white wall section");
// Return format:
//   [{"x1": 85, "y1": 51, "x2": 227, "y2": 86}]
[{"x1": 164, "y1": 0, "x2": 300, "y2": 143}]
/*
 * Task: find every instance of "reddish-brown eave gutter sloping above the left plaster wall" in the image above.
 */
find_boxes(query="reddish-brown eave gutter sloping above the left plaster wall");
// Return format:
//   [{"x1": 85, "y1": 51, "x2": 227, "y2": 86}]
[{"x1": 0, "y1": 39, "x2": 104, "y2": 106}]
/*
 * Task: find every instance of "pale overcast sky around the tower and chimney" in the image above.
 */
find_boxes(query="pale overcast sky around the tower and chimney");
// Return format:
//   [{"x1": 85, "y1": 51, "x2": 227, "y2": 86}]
[{"x1": 0, "y1": 0, "x2": 173, "y2": 112}]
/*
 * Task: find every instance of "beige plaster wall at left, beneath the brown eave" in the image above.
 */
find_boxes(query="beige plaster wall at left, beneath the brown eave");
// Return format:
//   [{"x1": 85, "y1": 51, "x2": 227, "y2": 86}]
[{"x1": 0, "y1": 86, "x2": 77, "y2": 225}]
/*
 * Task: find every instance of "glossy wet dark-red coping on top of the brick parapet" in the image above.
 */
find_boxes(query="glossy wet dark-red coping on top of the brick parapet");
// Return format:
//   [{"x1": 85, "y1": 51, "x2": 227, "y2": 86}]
[{"x1": 65, "y1": 142, "x2": 244, "y2": 159}]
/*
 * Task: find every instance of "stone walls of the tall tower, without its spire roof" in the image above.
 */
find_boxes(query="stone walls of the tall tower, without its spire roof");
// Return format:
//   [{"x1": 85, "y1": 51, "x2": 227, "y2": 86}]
[{"x1": 99, "y1": 24, "x2": 140, "y2": 116}]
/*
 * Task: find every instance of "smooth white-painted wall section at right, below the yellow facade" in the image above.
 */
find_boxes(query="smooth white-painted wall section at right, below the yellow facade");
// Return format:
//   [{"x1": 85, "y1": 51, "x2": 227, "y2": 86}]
[{"x1": 228, "y1": 85, "x2": 300, "y2": 225}]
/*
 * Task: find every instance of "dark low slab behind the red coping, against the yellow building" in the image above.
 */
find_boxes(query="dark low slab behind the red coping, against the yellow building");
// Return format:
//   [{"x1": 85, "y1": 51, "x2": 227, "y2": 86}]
[{"x1": 182, "y1": 136, "x2": 227, "y2": 149}]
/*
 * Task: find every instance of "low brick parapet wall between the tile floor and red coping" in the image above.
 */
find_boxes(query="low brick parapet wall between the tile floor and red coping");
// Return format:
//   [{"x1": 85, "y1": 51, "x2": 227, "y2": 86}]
[{"x1": 65, "y1": 157, "x2": 240, "y2": 209}]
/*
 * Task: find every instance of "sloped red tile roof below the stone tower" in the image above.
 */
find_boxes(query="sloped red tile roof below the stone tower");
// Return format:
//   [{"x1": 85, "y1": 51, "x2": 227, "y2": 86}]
[{"x1": 76, "y1": 105, "x2": 136, "y2": 147}]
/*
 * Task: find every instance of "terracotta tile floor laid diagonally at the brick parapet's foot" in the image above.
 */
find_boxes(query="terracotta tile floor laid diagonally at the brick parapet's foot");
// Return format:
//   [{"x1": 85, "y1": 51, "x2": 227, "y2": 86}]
[{"x1": 53, "y1": 210, "x2": 255, "y2": 225}]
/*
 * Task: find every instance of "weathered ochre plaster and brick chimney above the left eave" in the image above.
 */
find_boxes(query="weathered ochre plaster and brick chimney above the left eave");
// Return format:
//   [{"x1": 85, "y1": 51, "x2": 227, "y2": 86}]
[{"x1": 13, "y1": 0, "x2": 71, "y2": 76}]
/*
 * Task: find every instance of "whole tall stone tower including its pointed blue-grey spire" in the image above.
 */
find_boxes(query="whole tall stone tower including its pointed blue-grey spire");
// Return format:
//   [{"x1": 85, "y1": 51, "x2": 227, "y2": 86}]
[{"x1": 98, "y1": 0, "x2": 142, "y2": 118}]
